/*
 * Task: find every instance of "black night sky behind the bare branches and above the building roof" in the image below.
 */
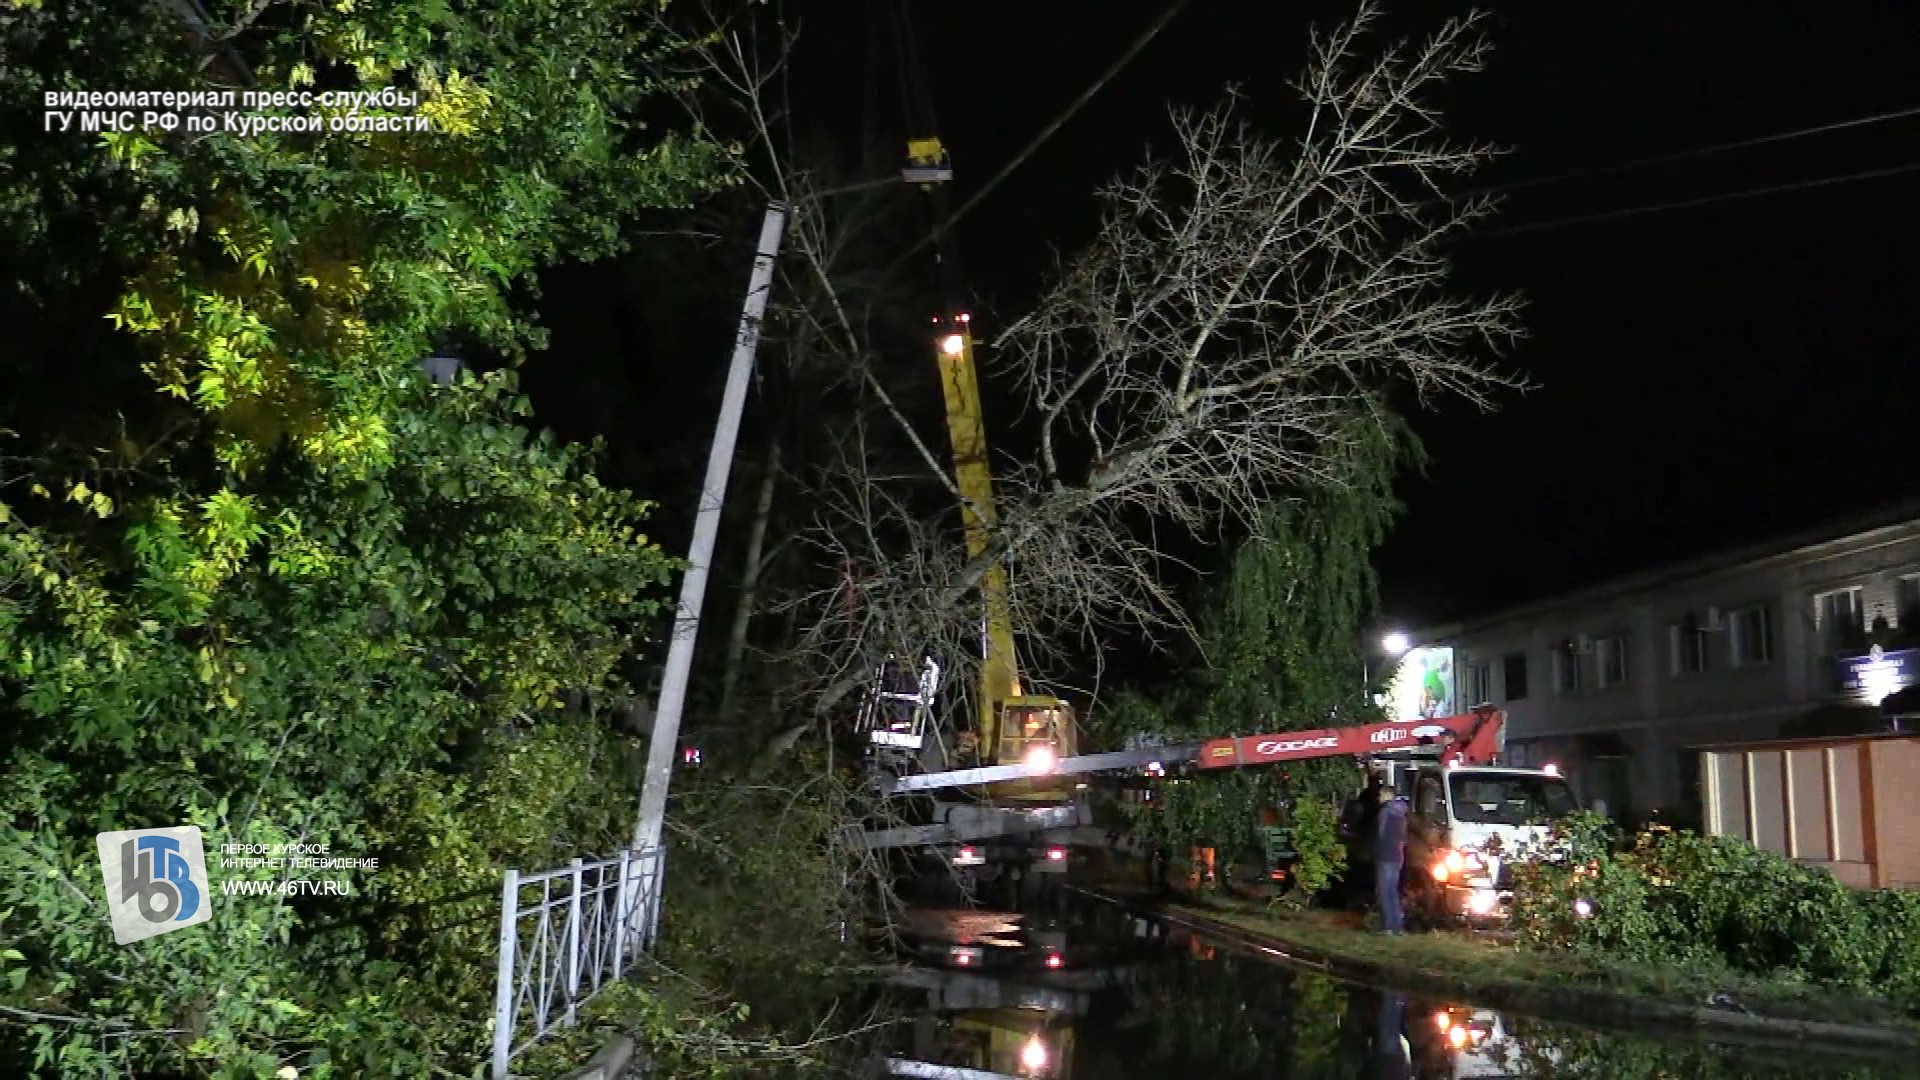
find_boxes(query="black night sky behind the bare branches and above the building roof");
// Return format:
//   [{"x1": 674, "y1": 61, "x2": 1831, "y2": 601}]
[{"x1": 528, "y1": 0, "x2": 1920, "y2": 625}]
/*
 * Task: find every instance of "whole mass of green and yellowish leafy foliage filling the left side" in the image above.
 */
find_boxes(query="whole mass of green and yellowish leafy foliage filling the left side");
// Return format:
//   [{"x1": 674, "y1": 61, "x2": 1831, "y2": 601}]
[{"x1": 0, "y1": 0, "x2": 756, "y2": 1076}]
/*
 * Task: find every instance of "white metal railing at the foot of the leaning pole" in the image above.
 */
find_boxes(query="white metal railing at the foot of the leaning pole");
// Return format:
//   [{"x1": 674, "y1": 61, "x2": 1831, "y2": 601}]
[{"x1": 492, "y1": 847, "x2": 666, "y2": 1080}]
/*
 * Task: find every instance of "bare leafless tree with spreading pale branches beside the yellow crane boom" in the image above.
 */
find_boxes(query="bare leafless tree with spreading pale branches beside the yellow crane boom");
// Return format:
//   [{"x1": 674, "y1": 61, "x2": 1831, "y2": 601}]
[{"x1": 675, "y1": 2, "x2": 1524, "y2": 749}]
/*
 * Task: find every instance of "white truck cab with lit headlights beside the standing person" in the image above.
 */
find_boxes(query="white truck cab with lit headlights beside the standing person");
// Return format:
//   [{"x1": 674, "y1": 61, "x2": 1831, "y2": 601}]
[{"x1": 1396, "y1": 763, "x2": 1580, "y2": 924}]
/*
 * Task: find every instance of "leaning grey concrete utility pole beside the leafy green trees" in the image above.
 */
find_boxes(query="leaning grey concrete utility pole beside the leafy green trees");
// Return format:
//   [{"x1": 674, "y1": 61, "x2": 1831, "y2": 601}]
[{"x1": 634, "y1": 202, "x2": 787, "y2": 851}]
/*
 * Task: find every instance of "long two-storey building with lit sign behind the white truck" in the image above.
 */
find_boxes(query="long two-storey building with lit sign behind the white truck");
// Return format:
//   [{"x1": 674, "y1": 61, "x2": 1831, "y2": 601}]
[{"x1": 1413, "y1": 502, "x2": 1920, "y2": 819}]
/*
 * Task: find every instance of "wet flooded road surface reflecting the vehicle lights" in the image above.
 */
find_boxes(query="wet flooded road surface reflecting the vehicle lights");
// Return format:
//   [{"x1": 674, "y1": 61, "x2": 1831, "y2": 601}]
[{"x1": 881, "y1": 894, "x2": 1920, "y2": 1080}]
